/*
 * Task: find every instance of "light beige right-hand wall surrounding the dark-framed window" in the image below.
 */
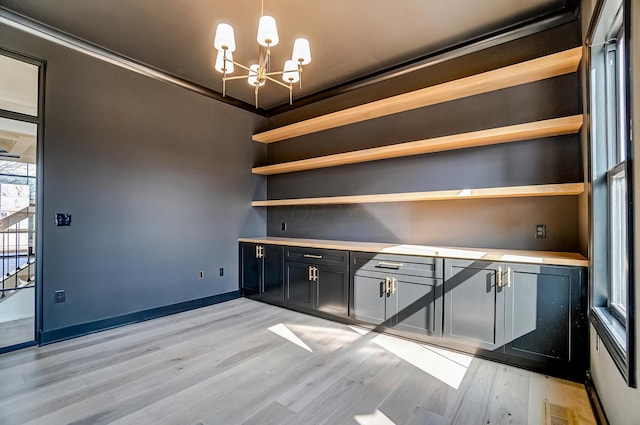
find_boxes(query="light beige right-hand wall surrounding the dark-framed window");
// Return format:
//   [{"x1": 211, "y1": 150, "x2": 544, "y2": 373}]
[{"x1": 582, "y1": 0, "x2": 640, "y2": 425}]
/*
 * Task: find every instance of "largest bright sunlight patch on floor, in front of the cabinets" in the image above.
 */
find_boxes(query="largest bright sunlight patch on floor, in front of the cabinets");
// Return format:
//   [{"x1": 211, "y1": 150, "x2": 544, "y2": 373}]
[{"x1": 372, "y1": 335, "x2": 473, "y2": 390}]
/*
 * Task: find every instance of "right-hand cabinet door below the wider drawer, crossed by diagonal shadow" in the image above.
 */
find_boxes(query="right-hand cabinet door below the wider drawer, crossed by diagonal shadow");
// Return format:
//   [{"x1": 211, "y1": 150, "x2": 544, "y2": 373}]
[{"x1": 387, "y1": 275, "x2": 442, "y2": 337}]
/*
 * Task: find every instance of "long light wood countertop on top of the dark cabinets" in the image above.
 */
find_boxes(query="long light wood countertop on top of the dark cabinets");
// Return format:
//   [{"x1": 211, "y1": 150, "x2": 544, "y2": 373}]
[{"x1": 238, "y1": 236, "x2": 589, "y2": 267}]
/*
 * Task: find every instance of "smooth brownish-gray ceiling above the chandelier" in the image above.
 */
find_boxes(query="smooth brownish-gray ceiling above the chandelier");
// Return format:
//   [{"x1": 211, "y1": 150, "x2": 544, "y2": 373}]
[{"x1": 0, "y1": 0, "x2": 574, "y2": 109}]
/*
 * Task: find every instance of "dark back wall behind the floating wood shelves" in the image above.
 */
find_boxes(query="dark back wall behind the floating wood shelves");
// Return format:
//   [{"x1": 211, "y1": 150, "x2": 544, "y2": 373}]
[{"x1": 265, "y1": 22, "x2": 584, "y2": 252}]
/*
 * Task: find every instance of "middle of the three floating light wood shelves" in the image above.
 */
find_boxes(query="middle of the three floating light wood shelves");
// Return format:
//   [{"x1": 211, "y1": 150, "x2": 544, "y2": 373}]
[{"x1": 251, "y1": 115, "x2": 582, "y2": 175}]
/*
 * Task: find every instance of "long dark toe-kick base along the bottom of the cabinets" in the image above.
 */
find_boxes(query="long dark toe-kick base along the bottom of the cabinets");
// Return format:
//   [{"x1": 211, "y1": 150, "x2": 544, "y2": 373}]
[{"x1": 248, "y1": 296, "x2": 587, "y2": 383}]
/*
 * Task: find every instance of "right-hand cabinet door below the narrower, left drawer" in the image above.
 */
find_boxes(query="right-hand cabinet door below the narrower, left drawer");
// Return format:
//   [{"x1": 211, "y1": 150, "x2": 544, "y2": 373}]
[{"x1": 316, "y1": 266, "x2": 349, "y2": 316}]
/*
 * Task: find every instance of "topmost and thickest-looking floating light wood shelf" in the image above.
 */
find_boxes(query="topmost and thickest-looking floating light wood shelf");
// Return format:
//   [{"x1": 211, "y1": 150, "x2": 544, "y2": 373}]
[{"x1": 253, "y1": 47, "x2": 582, "y2": 143}]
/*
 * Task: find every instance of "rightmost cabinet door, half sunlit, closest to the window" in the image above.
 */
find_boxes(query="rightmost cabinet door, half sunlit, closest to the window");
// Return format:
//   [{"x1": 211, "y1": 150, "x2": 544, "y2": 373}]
[{"x1": 505, "y1": 264, "x2": 581, "y2": 362}]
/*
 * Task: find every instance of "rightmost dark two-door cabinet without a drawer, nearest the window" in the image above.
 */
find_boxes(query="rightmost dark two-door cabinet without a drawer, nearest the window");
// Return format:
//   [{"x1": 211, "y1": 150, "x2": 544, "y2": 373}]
[{"x1": 444, "y1": 259, "x2": 587, "y2": 377}]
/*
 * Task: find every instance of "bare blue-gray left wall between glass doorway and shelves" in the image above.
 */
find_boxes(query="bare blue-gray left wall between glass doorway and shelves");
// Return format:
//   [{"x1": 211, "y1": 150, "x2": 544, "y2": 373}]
[{"x1": 0, "y1": 26, "x2": 266, "y2": 331}]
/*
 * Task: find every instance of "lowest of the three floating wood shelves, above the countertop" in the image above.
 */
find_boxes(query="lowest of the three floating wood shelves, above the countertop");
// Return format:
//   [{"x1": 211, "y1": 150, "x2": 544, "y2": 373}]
[{"x1": 251, "y1": 183, "x2": 584, "y2": 207}]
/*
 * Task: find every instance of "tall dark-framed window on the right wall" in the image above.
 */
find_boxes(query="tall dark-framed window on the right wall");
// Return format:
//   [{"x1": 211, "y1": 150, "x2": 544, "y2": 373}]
[{"x1": 587, "y1": 0, "x2": 635, "y2": 386}]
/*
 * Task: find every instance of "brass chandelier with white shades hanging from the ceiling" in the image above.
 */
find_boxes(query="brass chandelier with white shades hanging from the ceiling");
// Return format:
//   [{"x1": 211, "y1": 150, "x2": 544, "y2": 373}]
[{"x1": 213, "y1": 0, "x2": 311, "y2": 108}]
